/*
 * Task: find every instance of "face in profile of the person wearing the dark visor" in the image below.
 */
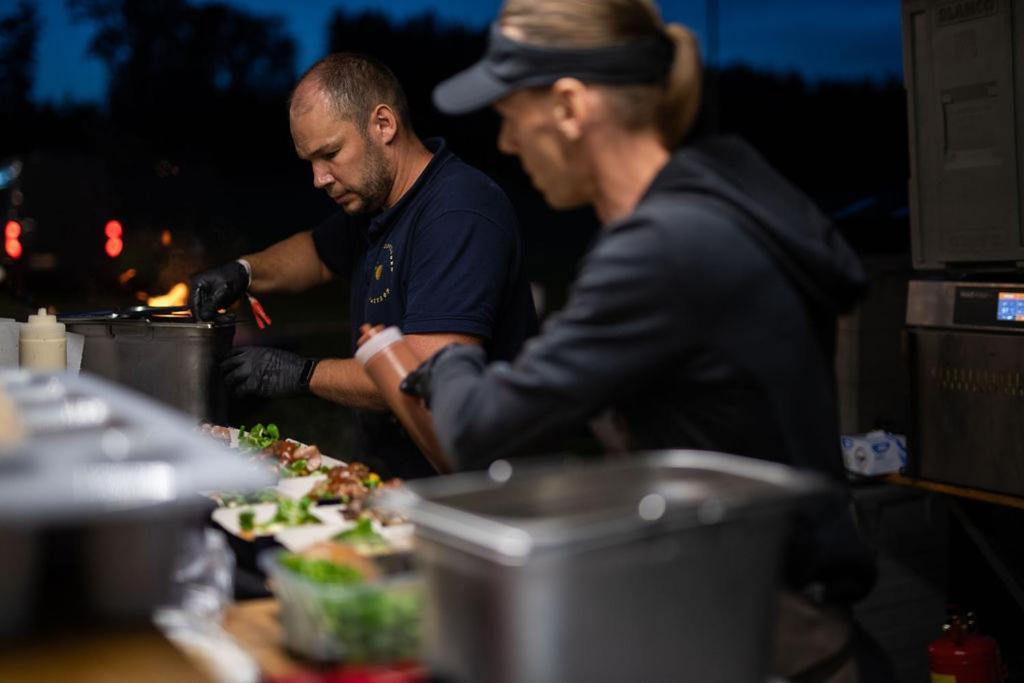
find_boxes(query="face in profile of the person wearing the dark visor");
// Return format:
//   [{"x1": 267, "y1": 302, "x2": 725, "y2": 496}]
[{"x1": 495, "y1": 89, "x2": 592, "y2": 209}]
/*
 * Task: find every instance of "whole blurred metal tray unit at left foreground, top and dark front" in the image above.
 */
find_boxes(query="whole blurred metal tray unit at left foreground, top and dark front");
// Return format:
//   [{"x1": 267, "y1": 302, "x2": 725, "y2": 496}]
[{"x1": 0, "y1": 371, "x2": 271, "y2": 637}]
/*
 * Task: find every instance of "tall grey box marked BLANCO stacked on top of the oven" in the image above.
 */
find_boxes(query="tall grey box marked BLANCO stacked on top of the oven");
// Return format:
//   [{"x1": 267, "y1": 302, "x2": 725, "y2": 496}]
[{"x1": 902, "y1": 0, "x2": 1024, "y2": 270}]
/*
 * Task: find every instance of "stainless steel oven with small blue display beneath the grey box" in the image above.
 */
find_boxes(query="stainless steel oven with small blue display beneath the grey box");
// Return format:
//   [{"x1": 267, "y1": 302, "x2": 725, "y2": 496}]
[{"x1": 907, "y1": 282, "x2": 1024, "y2": 496}]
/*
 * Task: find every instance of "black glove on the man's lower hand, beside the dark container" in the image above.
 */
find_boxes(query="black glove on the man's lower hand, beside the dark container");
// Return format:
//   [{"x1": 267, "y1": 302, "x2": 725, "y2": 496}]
[{"x1": 220, "y1": 346, "x2": 318, "y2": 398}]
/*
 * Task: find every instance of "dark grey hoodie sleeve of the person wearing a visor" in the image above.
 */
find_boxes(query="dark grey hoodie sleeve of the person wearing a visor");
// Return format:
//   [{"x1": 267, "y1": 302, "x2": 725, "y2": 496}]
[{"x1": 419, "y1": 219, "x2": 697, "y2": 467}]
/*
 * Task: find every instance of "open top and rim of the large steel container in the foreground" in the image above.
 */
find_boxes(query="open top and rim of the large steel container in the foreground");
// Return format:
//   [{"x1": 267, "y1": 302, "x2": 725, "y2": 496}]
[{"x1": 377, "y1": 451, "x2": 831, "y2": 566}]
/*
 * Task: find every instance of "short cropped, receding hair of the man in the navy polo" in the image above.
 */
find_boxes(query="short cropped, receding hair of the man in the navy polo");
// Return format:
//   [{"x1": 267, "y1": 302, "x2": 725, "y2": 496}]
[{"x1": 288, "y1": 52, "x2": 413, "y2": 133}]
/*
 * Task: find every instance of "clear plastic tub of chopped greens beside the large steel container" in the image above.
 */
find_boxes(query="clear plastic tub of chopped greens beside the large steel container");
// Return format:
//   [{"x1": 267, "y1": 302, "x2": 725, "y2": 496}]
[{"x1": 259, "y1": 551, "x2": 423, "y2": 663}]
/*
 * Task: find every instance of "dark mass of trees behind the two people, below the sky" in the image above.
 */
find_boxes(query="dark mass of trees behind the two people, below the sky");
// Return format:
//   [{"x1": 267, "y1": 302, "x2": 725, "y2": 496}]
[{"x1": 0, "y1": 0, "x2": 907, "y2": 306}]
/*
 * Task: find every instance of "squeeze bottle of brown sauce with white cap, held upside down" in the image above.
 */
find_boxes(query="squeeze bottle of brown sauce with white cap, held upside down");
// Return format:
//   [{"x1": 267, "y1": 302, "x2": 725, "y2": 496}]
[{"x1": 355, "y1": 326, "x2": 452, "y2": 474}]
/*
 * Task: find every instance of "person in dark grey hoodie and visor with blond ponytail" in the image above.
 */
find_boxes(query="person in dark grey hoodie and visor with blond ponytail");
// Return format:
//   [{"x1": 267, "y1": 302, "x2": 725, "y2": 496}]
[{"x1": 407, "y1": 0, "x2": 881, "y2": 682}]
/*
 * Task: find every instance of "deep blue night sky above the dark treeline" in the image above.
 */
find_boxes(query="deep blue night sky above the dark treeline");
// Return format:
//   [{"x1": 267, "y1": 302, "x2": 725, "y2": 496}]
[{"x1": 28, "y1": 0, "x2": 901, "y2": 103}]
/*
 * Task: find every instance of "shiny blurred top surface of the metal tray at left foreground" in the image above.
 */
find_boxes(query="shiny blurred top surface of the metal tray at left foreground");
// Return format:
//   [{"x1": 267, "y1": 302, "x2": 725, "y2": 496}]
[{"x1": 0, "y1": 370, "x2": 272, "y2": 528}]
